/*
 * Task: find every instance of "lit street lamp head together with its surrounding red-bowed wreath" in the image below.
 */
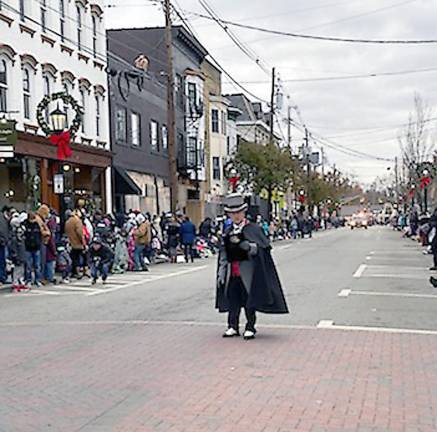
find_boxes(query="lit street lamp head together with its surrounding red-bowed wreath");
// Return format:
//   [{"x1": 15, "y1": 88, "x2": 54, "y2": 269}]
[{"x1": 36, "y1": 92, "x2": 84, "y2": 160}]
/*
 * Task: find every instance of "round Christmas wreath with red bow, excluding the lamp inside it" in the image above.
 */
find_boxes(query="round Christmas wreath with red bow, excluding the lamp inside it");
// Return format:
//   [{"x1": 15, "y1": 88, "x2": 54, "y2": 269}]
[{"x1": 36, "y1": 92, "x2": 84, "y2": 160}]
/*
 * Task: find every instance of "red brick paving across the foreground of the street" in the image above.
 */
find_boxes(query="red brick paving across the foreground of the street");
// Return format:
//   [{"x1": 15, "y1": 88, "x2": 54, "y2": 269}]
[{"x1": 0, "y1": 322, "x2": 437, "y2": 432}]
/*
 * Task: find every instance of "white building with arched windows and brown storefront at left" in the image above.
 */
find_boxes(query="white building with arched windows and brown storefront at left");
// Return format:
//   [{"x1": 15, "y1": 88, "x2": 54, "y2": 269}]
[{"x1": 0, "y1": 0, "x2": 112, "y2": 212}]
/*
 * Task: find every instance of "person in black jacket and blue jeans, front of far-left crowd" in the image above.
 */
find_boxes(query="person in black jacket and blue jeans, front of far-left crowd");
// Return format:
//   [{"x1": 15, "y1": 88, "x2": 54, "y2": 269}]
[{"x1": 24, "y1": 212, "x2": 42, "y2": 288}]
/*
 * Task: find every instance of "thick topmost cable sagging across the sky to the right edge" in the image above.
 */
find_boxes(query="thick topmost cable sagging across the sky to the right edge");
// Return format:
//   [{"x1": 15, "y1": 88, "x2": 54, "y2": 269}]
[{"x1": 183, "y1": 12, "x2": 437, "y2": 45}]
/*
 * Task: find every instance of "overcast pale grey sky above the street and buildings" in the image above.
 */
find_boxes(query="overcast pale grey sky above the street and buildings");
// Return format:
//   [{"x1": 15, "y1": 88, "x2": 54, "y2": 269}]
[{"x1": 106, "y1": 0, "x2": 437, "y2": 184}]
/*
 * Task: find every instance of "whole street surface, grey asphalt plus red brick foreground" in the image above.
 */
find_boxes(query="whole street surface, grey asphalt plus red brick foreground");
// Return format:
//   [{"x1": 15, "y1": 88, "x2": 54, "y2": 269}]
[{"x1": 0, "y1": 227, "x2": 437, "y2": 432}]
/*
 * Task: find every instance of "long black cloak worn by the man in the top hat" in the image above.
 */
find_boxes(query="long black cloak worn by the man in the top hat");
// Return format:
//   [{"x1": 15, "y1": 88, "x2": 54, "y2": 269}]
[{"x1": 216, "y1": 223, "x2": 288, "y2": 314}]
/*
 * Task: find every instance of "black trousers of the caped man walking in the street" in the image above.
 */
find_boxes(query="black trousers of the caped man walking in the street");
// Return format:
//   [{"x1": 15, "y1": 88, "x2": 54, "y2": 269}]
[{"x1": 228, "y1": 277, "x2": 256, "y2": 332}]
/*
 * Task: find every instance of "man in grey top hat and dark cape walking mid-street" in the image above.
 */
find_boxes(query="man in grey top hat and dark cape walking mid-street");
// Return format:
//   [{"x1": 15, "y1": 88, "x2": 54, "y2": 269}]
[{"x1": 216, "y1": 193, "x2": 288, "y2": 340}]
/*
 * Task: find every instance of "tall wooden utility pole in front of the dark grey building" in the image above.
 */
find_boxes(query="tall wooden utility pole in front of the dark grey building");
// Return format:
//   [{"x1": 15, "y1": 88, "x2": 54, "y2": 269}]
[{"x1": 164, "y1": 0, "x2": 178, "y2": 214}]
